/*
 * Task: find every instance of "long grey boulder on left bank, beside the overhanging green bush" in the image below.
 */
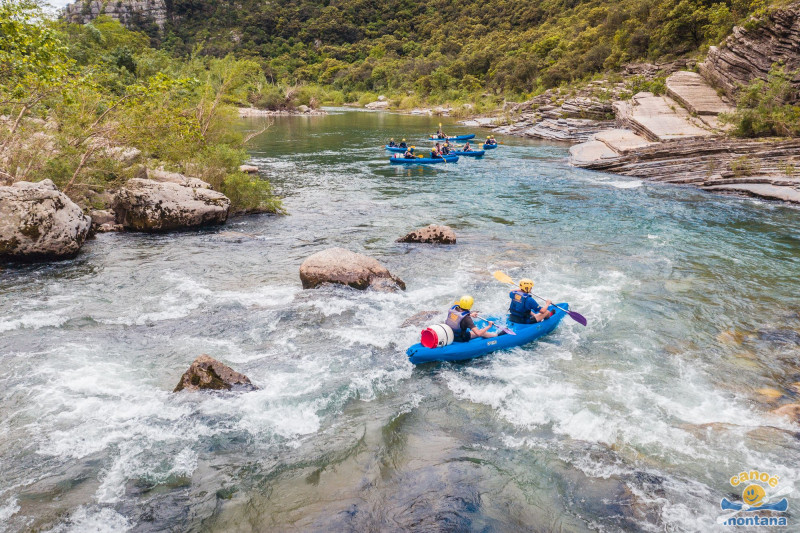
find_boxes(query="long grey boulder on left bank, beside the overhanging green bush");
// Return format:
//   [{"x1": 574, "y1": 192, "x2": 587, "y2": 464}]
[{"x1": 114, "y1": 178, "x2": 231, "y2": 232}]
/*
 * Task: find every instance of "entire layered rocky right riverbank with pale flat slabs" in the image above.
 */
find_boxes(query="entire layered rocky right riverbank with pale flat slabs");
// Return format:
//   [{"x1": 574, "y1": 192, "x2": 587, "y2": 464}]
[{"x1": 473, "y1": 3, "x2": 800, "y2": 203}]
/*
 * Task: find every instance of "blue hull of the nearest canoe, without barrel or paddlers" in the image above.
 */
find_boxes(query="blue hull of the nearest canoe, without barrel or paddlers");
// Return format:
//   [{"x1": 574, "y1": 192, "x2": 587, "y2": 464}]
[{"x1": 406, "y1": 303, "x2": 569, "y2": 365}]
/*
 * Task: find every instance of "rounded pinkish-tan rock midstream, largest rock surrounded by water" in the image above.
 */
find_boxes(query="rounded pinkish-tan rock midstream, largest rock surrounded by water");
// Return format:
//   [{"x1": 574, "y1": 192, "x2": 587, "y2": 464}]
[{"x1": 300, "y1": 248, "x2": 406, "y2": 290}]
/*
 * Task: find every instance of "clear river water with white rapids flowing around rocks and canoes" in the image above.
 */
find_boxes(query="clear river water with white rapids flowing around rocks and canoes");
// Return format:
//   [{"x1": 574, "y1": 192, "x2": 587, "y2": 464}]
[{"x1": 0, "y1": 112, "x2": 800, "y2": 531}]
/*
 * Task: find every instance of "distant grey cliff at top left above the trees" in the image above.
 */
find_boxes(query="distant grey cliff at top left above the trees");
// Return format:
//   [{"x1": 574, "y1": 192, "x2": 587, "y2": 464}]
[{"x1": 64, "y1": 0, "x2": 167, "y2": 29}]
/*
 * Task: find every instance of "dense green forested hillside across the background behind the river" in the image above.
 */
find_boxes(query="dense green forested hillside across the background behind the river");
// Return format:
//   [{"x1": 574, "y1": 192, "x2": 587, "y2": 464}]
[{"x1": 151, "y1": 0, "x2": 774, "y2": 107}]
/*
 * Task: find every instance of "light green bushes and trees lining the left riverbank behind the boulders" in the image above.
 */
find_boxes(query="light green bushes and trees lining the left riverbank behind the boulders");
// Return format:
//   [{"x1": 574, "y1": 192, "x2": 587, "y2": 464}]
[{"x1": 0, "y1": 0, "x2": 280, "y2": 211}]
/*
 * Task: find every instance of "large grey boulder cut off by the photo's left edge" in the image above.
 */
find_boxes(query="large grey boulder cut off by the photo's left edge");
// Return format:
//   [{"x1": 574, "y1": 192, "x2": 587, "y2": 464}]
[{"x1": 0, "y1": 180, "x2": 92, "y2": 259}]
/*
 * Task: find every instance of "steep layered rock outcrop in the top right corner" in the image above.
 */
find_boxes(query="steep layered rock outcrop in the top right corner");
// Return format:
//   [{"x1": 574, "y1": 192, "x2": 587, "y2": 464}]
[{"x1": 699, "y1": 2, "x2": 800, "y2": 100}]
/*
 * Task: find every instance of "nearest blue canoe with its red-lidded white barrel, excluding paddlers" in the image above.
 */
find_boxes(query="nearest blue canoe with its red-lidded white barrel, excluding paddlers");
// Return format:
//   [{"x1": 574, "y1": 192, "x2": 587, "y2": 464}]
[{"x1": 406, "y1": 303, "x2": 569, "y2": 365}]
